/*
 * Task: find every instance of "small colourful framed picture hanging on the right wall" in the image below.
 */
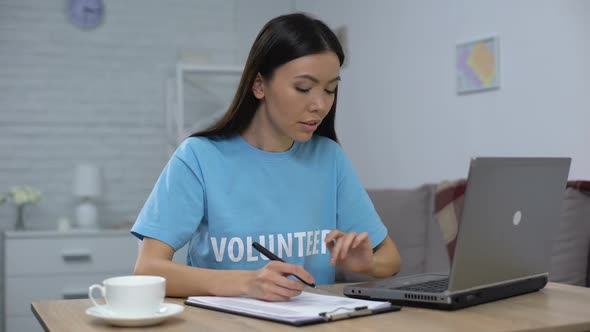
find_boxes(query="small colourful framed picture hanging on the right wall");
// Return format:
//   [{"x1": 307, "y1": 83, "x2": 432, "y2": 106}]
[{"x1": 456, "y1": 37, "x2": 500, "y2": 94}]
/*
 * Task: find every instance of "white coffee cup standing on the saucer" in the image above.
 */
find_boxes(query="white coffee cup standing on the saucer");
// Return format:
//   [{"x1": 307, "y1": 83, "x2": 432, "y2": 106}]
[{"x1": 88, "y1": 276, "x2": 166, "y2": 317}]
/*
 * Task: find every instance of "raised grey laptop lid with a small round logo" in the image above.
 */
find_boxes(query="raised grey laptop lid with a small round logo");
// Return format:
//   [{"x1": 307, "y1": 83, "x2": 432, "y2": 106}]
[{"x1": 449, "y1": 158, "x2": 571, "y2": 292}]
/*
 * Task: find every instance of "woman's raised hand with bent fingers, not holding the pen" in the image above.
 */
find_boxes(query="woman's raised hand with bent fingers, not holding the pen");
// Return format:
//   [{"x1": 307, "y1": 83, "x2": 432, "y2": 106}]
[{"x1": 325, "y1": 229, "x2": 373, "y2": 274}]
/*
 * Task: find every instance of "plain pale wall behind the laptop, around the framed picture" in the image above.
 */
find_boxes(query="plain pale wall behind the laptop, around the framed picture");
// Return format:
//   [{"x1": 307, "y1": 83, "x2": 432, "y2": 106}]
[{"x1": 295, "y1": 0, "x2": 590, "y2": 188}]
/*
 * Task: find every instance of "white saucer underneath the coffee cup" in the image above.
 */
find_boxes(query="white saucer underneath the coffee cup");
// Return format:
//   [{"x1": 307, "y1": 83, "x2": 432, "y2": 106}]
[{"x1": 86, "y1": 303, "x2": 184, "y2": 326}]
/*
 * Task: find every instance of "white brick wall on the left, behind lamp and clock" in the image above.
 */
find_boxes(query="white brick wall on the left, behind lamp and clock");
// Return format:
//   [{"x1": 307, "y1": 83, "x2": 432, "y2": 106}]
[{"x1": 0, "y1": 0, "x2": 294, "y2": 230}]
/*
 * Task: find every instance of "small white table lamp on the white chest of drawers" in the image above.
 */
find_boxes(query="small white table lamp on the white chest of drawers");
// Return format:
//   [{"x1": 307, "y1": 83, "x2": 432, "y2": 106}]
[{"x1": 73, "y1": 163, "x2": 101, "y2": 229}]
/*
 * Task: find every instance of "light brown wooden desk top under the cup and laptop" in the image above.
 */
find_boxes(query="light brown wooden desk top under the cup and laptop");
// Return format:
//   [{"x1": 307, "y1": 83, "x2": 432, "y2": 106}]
[{"x1": 32, "y1": 283, "x2": 590, "y2": 332}]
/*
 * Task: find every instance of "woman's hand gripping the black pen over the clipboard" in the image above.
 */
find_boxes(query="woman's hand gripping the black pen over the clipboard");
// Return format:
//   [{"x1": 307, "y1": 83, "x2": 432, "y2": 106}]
[{"x1": 246, "y1": 261, "x2": 315, "y2": 302}]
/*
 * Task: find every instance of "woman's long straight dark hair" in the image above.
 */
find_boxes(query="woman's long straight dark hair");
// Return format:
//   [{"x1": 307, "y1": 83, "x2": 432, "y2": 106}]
[{"x1": 191, "y1": 13, "x2": 344, "y2": 142}]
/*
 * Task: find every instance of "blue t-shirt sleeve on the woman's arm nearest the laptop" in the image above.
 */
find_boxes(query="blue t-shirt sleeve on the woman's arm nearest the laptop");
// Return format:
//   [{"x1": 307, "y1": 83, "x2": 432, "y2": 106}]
[{"x1": 336, "y1": 146, "x2": 387, "y2": 248}]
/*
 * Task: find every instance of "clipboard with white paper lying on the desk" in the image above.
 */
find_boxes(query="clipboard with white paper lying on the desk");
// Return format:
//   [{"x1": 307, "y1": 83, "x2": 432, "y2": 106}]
[{"x1": 184, "y1": 292, "x2": 401, "y2": 326}]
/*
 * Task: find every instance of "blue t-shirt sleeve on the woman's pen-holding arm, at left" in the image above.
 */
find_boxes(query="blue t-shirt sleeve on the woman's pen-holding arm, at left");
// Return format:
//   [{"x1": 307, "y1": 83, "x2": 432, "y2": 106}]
[{"x1": 131, "y1": 144, "x2": 205, "y2": 250}]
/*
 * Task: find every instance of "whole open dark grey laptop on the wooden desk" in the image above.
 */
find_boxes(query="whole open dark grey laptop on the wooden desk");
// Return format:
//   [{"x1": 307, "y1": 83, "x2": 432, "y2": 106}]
[{"x1": 344, "y1": 157, "x2": 571, "y2": 310}]
